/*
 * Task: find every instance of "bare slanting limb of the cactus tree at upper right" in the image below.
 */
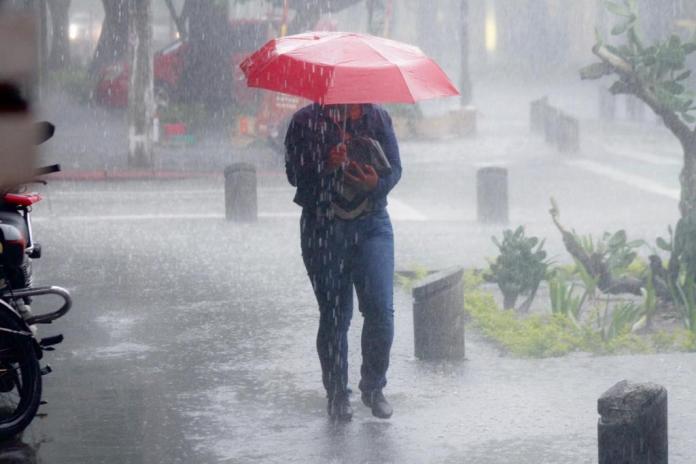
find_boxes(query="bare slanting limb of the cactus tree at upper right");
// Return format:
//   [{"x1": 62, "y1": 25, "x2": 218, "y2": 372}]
[{"x1": 592, "y1": 45, "x2": 694, "y2": 147}]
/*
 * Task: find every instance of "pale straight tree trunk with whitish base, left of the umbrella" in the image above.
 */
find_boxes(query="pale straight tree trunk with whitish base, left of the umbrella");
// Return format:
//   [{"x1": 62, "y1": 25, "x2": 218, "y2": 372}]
[{"x1": 128, "y1": 0, "x2": 155, "y2": 168}]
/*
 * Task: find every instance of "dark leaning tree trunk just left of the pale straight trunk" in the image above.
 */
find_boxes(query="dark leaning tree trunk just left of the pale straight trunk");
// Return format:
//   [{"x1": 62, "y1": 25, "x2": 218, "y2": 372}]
[{"x1": 89, "y1": 0, "x2": 128, "y2": 77}]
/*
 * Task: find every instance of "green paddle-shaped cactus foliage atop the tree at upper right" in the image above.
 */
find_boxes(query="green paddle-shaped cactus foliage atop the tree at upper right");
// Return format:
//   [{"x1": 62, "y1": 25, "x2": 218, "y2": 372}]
[{"x1": 581, "y1": 0, "x2": 696, "y2": 124}]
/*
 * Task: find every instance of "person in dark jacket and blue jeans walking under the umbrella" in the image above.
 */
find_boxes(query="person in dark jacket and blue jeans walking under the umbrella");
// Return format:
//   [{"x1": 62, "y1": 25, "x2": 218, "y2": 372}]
[{"x1": 285, "y1": 103, "x2": 401, "y2": 420}]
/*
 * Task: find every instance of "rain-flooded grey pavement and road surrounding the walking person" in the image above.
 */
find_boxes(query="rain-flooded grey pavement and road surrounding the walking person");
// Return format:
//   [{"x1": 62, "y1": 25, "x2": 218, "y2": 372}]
[{"x1": 0, "y1": 74, "x2": 696, "y2": 464}]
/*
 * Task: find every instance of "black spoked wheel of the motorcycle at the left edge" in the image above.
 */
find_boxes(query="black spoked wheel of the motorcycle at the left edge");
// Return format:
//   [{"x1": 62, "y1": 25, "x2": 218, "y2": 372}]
[{"x1": 0, "y1": 304, "x2": 41, "y2": 440}]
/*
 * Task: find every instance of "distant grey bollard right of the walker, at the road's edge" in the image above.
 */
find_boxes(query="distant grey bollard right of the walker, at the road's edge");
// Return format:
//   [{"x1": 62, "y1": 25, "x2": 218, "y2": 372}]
[{"x1": 476, "y1": 166, "x2": 508, "y2": 224}]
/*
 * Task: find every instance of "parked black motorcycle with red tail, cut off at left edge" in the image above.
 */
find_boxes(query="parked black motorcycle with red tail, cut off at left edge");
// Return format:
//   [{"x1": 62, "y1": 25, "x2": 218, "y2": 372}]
[{"x1": 0, "y1": 123, "x2": 72, "y2": 440}]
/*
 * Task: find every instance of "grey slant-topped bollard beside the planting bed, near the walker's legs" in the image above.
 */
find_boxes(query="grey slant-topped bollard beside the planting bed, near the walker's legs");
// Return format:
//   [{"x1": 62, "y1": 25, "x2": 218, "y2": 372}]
[{"x1": 412, "y1": 267, "x2": 464, "y2": 360}]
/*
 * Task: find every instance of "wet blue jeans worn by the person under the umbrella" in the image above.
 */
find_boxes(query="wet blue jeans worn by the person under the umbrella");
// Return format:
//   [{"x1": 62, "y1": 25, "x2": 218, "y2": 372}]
[{"x1": 300, "y1": 209, "x2": 394, "y2": 398}]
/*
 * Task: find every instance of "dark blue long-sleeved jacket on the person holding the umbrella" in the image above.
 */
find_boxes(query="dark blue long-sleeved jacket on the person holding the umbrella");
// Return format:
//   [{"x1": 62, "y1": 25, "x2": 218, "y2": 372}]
[{"x1": 285, "y1": 103, "x2": 401, "y2": 210}]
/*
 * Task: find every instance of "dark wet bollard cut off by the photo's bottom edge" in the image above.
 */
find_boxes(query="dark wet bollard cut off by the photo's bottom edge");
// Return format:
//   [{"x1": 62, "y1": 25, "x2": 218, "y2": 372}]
[{"x1": 597, "y1": 380, "x2": 668, "y2": 464}]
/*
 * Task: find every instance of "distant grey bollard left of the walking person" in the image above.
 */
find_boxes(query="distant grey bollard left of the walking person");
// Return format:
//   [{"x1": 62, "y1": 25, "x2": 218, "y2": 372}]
[{"x1": 225, "y1": 163, "x2": 258, "y2": 222}]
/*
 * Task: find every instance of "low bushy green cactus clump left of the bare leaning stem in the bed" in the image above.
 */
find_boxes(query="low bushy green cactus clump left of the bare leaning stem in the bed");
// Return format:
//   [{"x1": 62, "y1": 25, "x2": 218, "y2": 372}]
[{"x1": 484, "y1": 226, "x2": 548, "y2": 309}]
